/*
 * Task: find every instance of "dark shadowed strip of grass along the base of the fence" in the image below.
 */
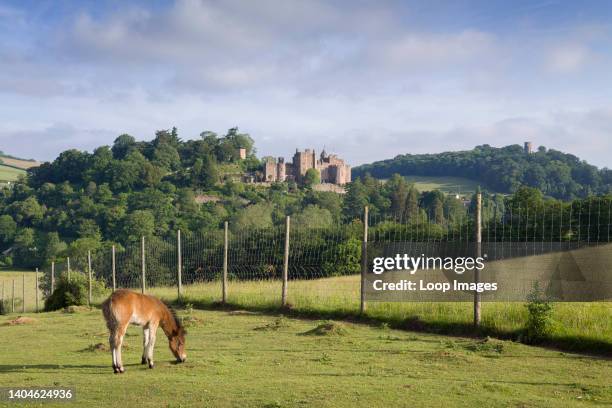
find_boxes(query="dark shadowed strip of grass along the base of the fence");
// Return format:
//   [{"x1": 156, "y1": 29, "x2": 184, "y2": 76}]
[{"x1": 171, "y1": 297, "x2": 612, "y2": 358}]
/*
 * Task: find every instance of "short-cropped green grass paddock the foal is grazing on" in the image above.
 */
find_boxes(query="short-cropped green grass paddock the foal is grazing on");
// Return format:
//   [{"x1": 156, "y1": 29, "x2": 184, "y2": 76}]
[{"x1": 0, "y1": 310, "x2": 612, "y2": 407}]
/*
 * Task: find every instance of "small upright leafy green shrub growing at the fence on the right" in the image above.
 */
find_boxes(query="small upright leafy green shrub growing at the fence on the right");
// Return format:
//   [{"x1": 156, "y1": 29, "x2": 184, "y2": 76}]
[{"x1": 524, "y1": 282, "x2": 553, "y2": 343}]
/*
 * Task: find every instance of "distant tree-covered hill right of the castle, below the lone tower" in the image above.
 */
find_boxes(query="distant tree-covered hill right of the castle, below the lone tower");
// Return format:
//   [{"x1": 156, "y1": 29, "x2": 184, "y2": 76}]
[{"x1": 353, "y1": 145, "x2": 612, "y2": 200}]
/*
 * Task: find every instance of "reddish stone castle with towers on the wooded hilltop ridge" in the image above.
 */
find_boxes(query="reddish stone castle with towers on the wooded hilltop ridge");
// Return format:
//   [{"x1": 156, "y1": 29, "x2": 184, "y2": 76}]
[{"x1": 264, "y1": 149, "x2": 351, "y2": 185}]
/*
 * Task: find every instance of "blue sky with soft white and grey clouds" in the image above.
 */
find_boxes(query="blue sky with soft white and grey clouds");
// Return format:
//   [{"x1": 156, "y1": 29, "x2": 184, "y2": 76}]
[{"x1": 0, "y1": 0, "x2": 612, "y2": 167}]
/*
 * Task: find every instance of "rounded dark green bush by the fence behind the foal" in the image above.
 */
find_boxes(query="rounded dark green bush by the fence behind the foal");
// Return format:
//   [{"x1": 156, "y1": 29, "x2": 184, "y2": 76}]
[{"x1": 45, "y1": 271, "x2": 106, "y2": 311}]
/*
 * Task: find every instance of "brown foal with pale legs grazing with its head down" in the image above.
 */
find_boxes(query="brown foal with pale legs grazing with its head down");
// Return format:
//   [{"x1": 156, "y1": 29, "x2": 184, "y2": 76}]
[{"x1": 102, "y1": 289, "x2": 187, "y2": 373}]
